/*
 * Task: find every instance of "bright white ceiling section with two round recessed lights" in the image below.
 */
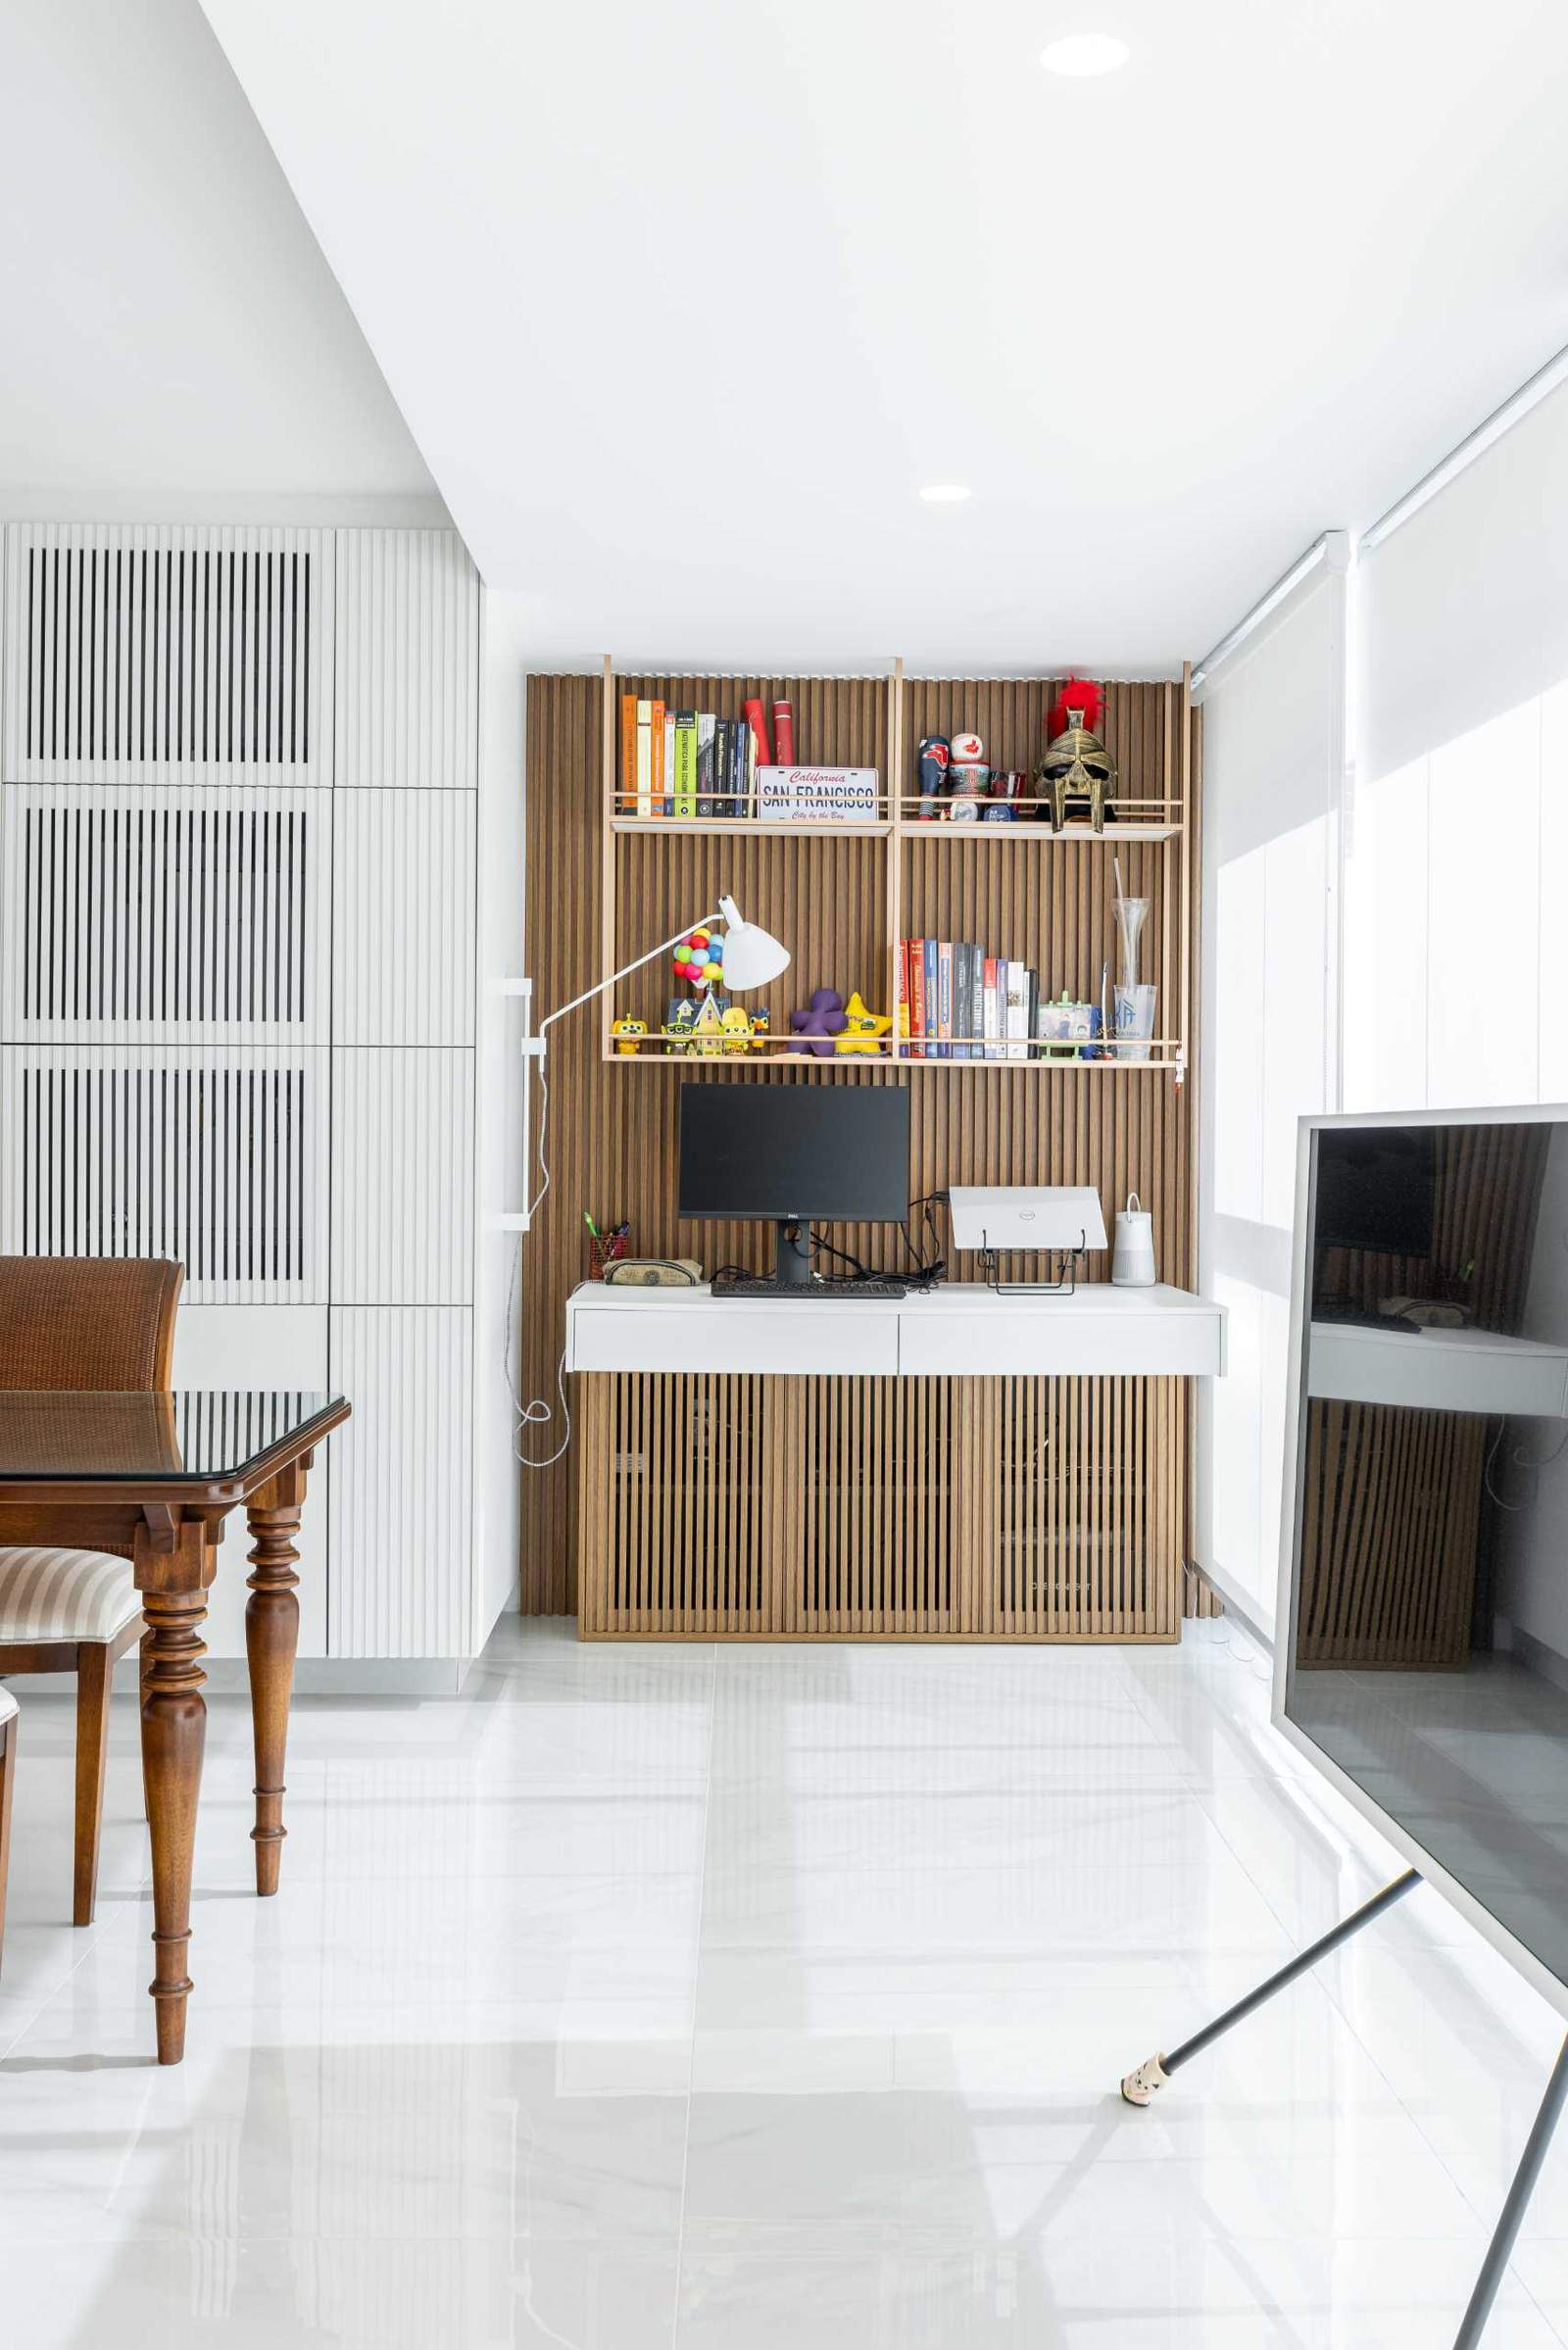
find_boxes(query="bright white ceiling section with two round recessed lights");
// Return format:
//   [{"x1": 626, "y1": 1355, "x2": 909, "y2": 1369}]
[{"x1": 202, "y1": 0, "x2": 1568, "y2": 672}]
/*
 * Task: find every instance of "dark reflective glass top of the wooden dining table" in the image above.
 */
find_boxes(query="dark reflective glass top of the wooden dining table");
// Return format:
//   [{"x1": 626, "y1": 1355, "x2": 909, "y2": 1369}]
[{"x1": 0, "y1": 1387, "x2": 348, "y2": 1486}]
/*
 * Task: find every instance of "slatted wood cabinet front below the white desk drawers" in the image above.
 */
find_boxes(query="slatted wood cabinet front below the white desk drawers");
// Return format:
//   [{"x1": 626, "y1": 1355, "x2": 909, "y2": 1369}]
[{"x1": 578, "y1": 1372, "x2": 1183, "y2": 1640}]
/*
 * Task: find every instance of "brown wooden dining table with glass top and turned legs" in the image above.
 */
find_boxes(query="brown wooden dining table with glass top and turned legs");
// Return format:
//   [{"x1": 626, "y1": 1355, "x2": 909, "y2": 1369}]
[{"x1": 0, "y1": 1389, "x2": 350, "y2": 2063}]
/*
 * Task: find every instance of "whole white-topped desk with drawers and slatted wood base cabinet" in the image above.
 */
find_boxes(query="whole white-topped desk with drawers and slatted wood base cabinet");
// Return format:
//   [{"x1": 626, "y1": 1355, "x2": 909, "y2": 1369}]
[{"x1": 566, "y1": 1283, "x2": 1225, "y2": 1640}]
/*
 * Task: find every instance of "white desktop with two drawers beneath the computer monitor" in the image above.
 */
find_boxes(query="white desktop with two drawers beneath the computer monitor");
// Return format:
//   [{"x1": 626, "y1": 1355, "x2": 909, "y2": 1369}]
[{"x1": 566, "y1": 1281, "x2": 1222, "y2": 1380}]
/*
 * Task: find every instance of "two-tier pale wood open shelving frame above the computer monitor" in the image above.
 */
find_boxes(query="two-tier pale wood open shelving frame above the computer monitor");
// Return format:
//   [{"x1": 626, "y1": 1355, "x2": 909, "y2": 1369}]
[{"x1": 600, "y1": 658, "x2": 1195, "y2": 1086}]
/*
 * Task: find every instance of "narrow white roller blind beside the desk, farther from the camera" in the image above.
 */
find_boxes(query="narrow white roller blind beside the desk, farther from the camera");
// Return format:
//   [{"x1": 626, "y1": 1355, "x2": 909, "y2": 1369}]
[{"x1": 1195, "y1": 562, "x2": 1345, "y2": 1629}]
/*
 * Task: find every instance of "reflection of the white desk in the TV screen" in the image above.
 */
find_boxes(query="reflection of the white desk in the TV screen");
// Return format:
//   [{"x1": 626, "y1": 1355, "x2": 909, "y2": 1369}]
[{"x1": 1307, "y1": 1321, "x2": 1568, "y2": 1419}]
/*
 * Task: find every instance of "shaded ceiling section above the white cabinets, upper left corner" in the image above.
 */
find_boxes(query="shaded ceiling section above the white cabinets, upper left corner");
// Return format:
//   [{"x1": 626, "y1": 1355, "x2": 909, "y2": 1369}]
[{"x1": 0, "y1": 0, "x2": 435, "y2": 519}]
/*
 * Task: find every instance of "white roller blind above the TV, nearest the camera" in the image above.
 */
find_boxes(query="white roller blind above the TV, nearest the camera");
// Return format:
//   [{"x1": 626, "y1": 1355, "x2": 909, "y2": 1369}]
[{"x1": 1345, "y1": 388, "x2": 1568, "y2": 1109}]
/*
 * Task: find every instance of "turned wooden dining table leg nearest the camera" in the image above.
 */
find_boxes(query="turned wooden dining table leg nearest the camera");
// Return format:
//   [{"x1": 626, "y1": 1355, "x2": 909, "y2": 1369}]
[{"x1": 136, "y1": 1518, "x2": 214, "y2": 2063}]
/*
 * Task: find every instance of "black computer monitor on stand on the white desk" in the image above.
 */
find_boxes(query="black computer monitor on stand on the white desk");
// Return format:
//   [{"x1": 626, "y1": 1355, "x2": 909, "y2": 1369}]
[{"x1": 679, "y1": 1079, "x2": 909, "y2": 1288}]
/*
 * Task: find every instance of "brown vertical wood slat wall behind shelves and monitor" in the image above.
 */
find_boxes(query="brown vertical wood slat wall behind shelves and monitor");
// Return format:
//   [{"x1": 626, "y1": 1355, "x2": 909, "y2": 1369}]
[{"x1": 522, "y1": 674, "x2": 1199, "y2": 1614}]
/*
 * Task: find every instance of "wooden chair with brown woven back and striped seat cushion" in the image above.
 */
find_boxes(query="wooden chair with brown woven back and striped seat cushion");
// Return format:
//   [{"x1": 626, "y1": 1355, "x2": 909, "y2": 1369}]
[{"x1": 0, "y1": 1257, "x2": 186, "y2": 1925}]
